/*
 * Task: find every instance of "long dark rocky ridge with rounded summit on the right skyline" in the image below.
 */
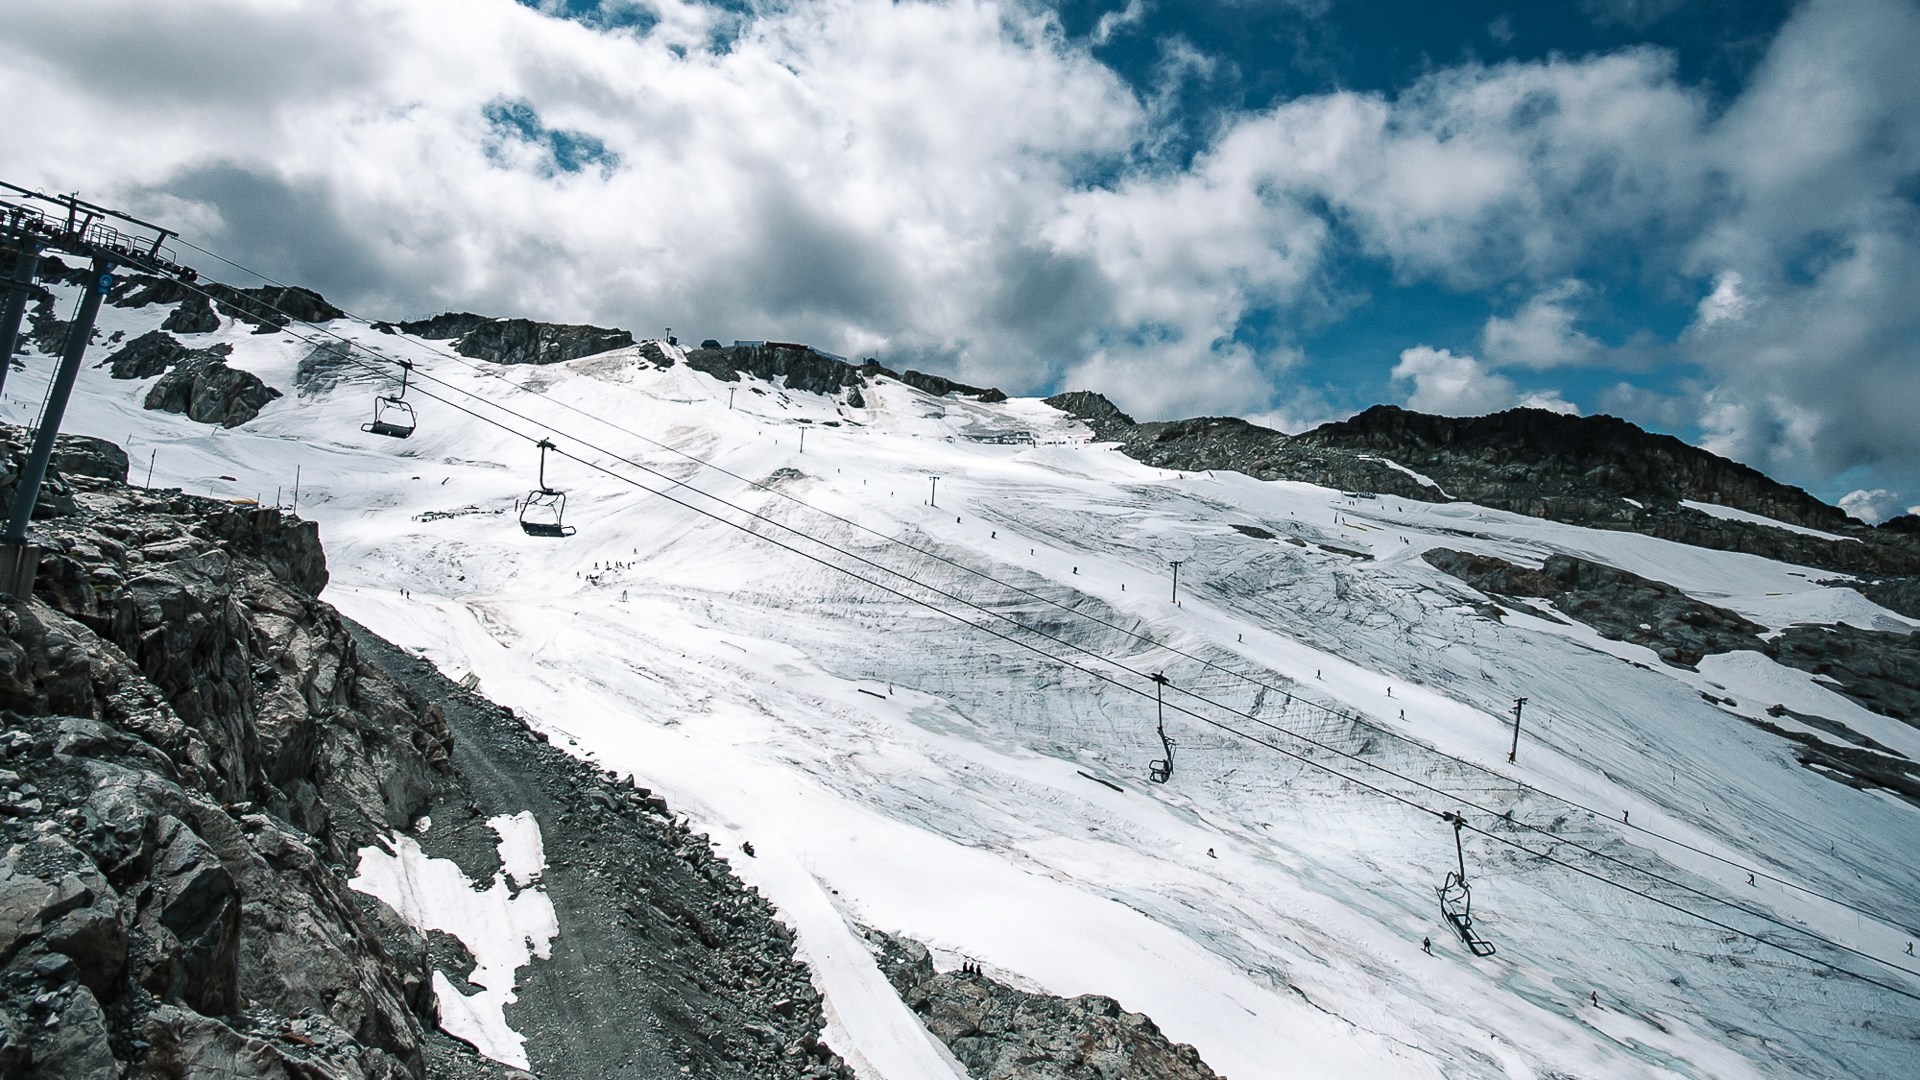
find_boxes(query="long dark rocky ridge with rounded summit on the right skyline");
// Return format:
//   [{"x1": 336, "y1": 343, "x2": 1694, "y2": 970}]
[{"x1": 1046, "y1": 390, "x2": 1920, "y2": 617}]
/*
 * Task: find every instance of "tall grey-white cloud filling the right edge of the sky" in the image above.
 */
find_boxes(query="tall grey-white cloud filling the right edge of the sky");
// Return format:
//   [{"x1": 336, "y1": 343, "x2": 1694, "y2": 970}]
[{"x1": 1680, "y1": 0, "x2": 1920, "y2": 479}]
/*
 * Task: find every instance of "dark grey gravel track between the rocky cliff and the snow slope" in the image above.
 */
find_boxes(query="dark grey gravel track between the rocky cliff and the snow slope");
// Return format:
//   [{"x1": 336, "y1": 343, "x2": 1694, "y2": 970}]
[{"x1": 351, "y1": 625, "x2": 851, "y2": 1080}]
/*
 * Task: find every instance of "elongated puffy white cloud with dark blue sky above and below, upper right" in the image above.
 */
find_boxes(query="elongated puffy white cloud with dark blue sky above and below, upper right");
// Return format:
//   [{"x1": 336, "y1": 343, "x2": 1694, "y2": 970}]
[{"x1": 1221, "y1": 48, "x2": 1711, "y2": 288}]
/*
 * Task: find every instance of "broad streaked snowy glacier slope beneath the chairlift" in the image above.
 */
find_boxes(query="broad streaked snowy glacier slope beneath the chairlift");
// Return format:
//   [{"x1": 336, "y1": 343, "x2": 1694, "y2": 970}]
[{"x1": 30, "y1": 292, "x2": 1920, "y2": 1080}]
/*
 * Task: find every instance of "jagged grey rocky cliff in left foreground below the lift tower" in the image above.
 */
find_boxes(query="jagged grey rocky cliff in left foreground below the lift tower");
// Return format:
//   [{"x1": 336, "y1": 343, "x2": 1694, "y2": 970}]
[{"x1": 0, "y1": 432, "x2": 449, "y2": 1078}]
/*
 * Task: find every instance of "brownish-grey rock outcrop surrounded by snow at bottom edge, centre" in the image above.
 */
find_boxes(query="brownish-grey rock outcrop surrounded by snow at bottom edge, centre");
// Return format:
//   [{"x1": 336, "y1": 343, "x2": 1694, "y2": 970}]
[{"x1": 866, "y1": 930, "x2": 1219, "y2": 1080}]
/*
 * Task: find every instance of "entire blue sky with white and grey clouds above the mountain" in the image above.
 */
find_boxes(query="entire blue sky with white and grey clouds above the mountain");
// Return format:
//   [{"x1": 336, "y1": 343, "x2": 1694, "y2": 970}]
[{"x1": 0, "y1": 0, "x2": 1920, "y2": 519}]
